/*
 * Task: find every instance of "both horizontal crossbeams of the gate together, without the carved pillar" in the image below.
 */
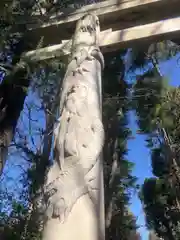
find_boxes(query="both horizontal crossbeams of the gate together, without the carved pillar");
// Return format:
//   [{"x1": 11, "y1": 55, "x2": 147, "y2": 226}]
[{"x1": 21, "y1": 0, "x2": 180, "y2": 61}]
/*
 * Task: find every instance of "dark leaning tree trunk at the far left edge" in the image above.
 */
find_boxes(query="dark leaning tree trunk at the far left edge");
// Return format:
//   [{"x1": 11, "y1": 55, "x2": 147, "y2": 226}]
[{"x1": 0, "y1": 37, "x2": 29, "y2": 175}]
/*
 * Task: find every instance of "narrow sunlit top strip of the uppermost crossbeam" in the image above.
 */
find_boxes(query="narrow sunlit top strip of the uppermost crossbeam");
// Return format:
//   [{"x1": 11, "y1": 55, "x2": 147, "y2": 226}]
[{"x1": 29, "y1": 0, "x2": 178, "y2": 29}]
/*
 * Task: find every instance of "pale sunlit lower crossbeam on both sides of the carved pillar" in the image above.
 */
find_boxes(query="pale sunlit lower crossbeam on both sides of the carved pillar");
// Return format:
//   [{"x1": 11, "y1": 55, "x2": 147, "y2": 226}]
[{"x1": 24, "y1": 17, "x2": 180, "y2": 61}]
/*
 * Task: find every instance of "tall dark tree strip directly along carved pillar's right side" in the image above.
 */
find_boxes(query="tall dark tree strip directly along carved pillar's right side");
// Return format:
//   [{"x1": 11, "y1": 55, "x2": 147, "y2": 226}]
[{"x1": 103, "y1": 52, "x2": 138, "y2": 240}]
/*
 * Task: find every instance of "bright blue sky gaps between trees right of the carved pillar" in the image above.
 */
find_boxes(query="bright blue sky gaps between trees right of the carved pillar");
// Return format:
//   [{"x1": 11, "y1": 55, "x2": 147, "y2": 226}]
[{"x1": 128, "y1": 54, "x2": 180, "y2": 240}]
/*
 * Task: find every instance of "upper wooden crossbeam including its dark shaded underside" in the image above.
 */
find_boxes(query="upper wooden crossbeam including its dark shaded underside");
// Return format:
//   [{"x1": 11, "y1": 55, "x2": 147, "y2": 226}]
[{"x1": 27, "y1": 0, "x2": 180, "y2": 47}]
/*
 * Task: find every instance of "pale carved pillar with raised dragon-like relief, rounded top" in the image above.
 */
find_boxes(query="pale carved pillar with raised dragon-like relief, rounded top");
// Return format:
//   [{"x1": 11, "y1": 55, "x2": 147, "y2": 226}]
[{"x1": 40, "y1": 14, "x2": 104, "y2": 240}]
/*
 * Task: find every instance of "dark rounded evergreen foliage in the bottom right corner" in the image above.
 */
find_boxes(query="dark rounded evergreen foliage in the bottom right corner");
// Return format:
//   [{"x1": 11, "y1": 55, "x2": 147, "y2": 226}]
[{"x1": 140, "y1": 178, "x2": 180, "y2": 239}]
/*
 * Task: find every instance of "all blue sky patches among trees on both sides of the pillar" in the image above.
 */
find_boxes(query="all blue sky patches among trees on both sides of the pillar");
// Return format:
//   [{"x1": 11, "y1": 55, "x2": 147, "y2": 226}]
[{"x1": 0, "y1": 50, "x2": 180, "y2": 240}]
